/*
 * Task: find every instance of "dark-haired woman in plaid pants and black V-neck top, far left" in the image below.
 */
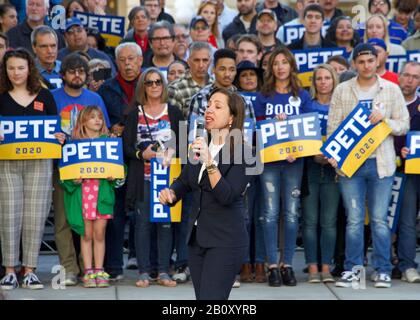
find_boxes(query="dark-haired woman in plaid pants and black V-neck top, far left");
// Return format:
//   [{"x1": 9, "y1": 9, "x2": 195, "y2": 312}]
[{"x1": 0, "y1": 48, "x2": 64, "y2": 290}]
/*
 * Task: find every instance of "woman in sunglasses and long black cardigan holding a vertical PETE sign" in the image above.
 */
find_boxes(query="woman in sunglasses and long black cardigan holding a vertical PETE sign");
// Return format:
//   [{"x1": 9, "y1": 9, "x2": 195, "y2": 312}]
[{"x1": 123, "y1": 67, "x2": 183, "y2": 288}]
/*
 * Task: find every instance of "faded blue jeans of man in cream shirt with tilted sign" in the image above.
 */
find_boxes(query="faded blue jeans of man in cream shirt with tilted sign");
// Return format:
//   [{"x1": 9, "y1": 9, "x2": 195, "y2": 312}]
[{"x1": 339, "y1": 159, "x2": 394, "y2": 274}]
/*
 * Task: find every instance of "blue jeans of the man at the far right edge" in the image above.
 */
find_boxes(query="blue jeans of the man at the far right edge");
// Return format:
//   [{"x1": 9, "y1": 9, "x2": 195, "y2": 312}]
[{"x1": 397, "y1": 174, "x2": 420, "y2": 272}]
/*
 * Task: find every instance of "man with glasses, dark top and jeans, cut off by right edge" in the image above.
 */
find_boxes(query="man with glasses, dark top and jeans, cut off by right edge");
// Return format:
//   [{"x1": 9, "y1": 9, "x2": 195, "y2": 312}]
[{"x1": 395, "y1": 61, "x2": 420, "y2": 283}]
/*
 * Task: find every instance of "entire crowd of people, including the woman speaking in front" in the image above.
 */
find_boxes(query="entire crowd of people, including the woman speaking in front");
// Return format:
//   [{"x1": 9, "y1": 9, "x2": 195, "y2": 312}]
[{"x1": 0, "y1": 0, "x2": 420, "y2": 299}]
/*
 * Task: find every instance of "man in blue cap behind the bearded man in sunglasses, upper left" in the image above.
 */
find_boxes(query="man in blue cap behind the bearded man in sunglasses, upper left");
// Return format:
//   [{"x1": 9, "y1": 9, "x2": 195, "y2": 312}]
[{"x1": 57, "y1": 17, "x2": 116, "y2": 76}]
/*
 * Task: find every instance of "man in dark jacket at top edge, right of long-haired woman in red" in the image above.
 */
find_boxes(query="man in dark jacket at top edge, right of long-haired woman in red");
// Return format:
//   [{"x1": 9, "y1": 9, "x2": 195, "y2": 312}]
[{"x1": 222, "y1": 0, "x2": 257, "y2": 43}]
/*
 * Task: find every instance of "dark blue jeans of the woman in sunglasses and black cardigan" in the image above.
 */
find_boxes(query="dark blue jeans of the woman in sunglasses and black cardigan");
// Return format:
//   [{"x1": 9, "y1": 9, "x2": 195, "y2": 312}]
[{"x1": 135, "y1": 181, "x2": 172, "y2": 273}]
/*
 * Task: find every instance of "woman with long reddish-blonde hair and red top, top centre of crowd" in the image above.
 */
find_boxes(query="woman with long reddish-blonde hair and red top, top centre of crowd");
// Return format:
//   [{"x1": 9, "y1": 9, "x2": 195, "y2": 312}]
[{"x1": 197, "y1": 0, "x2": 224, "y2": 49}]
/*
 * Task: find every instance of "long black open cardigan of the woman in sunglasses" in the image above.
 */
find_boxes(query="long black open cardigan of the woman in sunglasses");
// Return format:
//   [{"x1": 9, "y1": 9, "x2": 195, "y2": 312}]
[{"x1": 123, "y1": 104, "x2": 184, "y2": 212}]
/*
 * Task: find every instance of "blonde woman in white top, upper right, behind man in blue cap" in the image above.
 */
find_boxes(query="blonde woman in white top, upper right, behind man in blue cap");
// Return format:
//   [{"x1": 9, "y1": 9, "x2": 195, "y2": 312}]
[{"x1": 364, "y1": 14, "x2": 406, "y2": 56}]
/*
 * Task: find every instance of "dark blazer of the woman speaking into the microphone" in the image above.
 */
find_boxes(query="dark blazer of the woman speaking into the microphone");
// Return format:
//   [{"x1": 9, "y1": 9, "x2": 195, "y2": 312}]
[{"x1": 170, "y1": 143, "x2": 253, "y2": 248}]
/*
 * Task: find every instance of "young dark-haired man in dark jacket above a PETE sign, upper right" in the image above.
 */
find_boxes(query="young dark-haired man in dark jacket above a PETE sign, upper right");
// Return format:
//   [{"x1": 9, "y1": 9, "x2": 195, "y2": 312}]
[{"x1": 288, "y1": 4, "x2": 336, "y2": 50}]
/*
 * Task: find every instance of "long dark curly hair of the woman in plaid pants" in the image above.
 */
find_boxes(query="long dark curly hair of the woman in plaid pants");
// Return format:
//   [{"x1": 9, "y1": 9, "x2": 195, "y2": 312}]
[{"x1": 0, "y1": 48, "x2": 42, "y2": 95}]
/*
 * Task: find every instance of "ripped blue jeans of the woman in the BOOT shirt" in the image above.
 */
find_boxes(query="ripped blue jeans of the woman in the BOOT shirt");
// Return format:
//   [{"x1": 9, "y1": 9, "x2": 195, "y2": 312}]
[{"x1": 260, "y1": 158, "x2": 303, "y2": 265}]
